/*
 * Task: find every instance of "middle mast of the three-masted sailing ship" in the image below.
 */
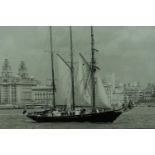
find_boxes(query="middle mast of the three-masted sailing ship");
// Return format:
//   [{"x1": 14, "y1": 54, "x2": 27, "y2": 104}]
[{"x1": 69, "y1": 26, "x2": 75, "y2": 110}]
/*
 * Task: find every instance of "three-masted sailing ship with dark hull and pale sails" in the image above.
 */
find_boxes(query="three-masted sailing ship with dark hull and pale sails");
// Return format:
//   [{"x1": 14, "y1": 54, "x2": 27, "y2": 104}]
[{"x1": 27, "y1": 27, "x2": 123, "y2": 122}]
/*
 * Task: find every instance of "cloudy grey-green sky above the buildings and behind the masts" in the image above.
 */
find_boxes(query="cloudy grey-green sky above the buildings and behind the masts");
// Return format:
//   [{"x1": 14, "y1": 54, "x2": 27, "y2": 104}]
[{"x1": 0, "y1": 27, "x2": 155, "y2": 84}]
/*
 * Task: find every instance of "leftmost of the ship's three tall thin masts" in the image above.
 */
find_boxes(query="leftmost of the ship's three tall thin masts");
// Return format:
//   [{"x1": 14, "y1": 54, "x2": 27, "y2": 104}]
[{"x1": 49, "y1": 26, "x2": 56, "y2": 108}]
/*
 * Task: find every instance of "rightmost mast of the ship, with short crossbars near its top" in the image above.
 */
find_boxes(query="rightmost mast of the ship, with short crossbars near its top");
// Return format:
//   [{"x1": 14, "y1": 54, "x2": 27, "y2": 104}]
[{"x1": 91, "y1": 26, "x2": 96, "y2": 110}]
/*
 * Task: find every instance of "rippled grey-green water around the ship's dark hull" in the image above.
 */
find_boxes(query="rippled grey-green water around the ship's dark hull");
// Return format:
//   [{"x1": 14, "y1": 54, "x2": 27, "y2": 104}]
[{"x1": 0, "y1": 106, "x2": 155, "y2": 129}]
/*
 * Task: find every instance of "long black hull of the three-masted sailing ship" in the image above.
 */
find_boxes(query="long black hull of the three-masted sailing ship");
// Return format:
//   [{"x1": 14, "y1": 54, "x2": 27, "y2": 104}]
[{"x1": 27, "y1": 111, "x2": 122, "y2": 123}]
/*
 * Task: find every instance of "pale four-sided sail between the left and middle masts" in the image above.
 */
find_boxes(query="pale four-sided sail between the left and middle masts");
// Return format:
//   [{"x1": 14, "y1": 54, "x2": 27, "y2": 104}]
[{"x1": 57, "y1": 56, "x2": 72, "y2": 108}]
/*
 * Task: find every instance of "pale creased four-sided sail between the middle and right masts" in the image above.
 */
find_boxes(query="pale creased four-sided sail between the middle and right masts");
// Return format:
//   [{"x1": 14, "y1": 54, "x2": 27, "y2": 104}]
[{"x1": 76, "y1": 56, "x2": 91, "y2": 105}]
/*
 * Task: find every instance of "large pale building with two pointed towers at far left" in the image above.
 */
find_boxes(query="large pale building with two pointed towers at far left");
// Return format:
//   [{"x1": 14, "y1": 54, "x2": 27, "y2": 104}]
[{"x1": 0, "y1": 59, "x2": 37, "y2": 106}]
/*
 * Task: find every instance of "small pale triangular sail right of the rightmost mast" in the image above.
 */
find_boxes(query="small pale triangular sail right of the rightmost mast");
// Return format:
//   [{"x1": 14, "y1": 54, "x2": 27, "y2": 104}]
[{"x1": 96, "y1": 73, "x2": 112, "y2": 109}]
